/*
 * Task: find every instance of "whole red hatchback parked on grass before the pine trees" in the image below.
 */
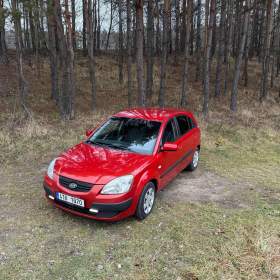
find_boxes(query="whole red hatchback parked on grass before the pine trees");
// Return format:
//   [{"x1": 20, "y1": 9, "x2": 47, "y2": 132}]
[{"x1": 44, "y1": 108, "x2": 200, "y2": 221}]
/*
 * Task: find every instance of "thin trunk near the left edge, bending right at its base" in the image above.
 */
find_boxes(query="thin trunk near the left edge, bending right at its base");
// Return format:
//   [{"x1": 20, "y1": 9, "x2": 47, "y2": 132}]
[{"x1": 12, "y1": 0, "x2": 31, "y2": 117}]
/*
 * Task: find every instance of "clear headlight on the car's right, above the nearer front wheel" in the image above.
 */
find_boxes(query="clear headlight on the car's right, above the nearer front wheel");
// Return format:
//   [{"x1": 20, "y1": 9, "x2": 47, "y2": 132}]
[{"x1": 101, "y1": 175, "x2": 133, "y2": 194}]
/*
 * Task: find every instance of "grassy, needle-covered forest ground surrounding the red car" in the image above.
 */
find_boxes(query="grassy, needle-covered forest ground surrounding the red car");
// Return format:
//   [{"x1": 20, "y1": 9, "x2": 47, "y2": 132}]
[{"x1": 0, "y1": 53, "x2": 280, "y2": 280}]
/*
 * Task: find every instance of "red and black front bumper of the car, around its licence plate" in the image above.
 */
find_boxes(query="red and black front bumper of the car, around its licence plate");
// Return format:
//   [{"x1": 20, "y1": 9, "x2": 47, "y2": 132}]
[{"x1": 43, "y1": 178, "x2": 135, "y2": 221}]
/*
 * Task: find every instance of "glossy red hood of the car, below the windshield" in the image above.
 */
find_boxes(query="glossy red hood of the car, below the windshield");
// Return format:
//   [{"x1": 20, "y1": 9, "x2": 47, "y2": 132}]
[{"x1": 55, "y1": 143, "x2": 152, "y2": 184}]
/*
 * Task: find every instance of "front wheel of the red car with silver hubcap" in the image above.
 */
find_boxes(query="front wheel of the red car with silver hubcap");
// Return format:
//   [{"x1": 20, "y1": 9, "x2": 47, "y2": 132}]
[{"x1": 135, "y1": 182, "x2": 156, "y2": 220}]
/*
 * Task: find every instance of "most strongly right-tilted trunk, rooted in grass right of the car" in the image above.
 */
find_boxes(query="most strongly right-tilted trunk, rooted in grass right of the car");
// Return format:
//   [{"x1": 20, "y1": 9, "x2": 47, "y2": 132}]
[{"x1": 230, "y1": 0, "x2": 250, "y2": 112}]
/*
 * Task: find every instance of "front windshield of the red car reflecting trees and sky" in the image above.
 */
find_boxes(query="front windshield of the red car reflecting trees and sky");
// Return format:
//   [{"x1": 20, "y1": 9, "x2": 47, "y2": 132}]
[{"x1": 88, "y1": 117, "x2": 161, "y2": 154}]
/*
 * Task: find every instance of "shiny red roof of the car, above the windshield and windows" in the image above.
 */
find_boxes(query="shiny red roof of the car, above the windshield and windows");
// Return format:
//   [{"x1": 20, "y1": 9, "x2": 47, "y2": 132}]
[{"x1": 114, "y1": 108, "x2": 192, "y2": 122}]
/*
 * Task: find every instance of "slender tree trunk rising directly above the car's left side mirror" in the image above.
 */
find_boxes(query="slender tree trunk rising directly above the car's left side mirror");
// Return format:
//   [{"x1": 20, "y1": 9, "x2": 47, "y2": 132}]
[{"x1": 85, "y1": 0, "x2": 96, "y2": 110}]
